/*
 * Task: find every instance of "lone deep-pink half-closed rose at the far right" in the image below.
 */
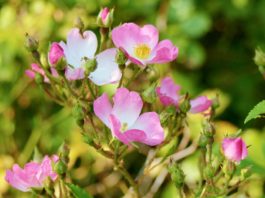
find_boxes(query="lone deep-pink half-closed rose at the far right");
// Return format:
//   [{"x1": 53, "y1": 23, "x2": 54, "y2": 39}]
[{"x1": 222, "y1": 138, "x2": 248, "y2": 162}]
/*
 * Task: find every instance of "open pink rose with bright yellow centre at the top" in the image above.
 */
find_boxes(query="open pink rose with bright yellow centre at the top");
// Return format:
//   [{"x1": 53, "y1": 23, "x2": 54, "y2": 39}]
[{"x1": 112, "y1": 23, "x2": 178, "y2": 66}]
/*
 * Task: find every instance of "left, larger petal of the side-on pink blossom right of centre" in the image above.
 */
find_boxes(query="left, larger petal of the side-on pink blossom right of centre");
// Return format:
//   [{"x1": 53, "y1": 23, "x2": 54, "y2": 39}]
[{"x1": 156, "y1": 77, "x2": 180, "y2": 106}]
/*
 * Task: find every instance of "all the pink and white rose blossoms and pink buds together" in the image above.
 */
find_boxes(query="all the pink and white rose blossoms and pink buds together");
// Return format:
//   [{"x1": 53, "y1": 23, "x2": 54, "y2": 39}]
[{"x1": 6, "y1": 8, "x2": 247, "y2": 197}]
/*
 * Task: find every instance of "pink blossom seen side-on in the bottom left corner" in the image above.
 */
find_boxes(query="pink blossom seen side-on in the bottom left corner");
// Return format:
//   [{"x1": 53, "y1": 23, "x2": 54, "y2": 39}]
[{"x1": 5, "y1": 155, "x2": 59, "y2": 192}]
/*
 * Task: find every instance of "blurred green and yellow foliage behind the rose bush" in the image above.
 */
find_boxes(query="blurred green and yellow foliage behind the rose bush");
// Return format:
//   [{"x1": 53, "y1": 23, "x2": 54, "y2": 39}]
[{"x1": 0, "y1": 0, "x2": 265, "y2": 197}]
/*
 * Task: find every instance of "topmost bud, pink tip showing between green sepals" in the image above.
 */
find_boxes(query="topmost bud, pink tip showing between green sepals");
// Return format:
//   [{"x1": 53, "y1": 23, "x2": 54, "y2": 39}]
[{"x1": 97, "y1": 7, "x2": 114, "y2": 27}]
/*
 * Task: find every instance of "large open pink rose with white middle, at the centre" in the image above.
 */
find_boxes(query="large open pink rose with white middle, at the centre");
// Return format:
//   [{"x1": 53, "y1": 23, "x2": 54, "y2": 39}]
[{"x1": 94, "y1": 88, "x2": 165, "y2": 146}]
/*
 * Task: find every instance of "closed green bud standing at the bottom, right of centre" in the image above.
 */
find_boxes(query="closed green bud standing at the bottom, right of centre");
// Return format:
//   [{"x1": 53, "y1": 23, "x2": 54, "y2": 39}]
[{"x1": 168, "y1": 164, "x2": 185, "y2": 188}]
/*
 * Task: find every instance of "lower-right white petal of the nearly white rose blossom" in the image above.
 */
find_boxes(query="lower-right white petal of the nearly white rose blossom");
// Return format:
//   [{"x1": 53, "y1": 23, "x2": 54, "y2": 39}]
[{"x1": 89, "y1": 48, "x2": 121, "y2": 85}]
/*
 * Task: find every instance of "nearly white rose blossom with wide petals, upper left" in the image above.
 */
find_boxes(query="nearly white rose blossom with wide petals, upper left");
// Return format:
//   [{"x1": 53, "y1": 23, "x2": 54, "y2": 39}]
[{"x1": 60, "y1": 28, "x2": 121, "y2": 85}]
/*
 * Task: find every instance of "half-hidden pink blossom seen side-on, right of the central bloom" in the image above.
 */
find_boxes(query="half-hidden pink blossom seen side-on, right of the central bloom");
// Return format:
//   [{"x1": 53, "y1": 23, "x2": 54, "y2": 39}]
[{"x1": 156, "y1": 77, "x2": 212, "y2": 113}]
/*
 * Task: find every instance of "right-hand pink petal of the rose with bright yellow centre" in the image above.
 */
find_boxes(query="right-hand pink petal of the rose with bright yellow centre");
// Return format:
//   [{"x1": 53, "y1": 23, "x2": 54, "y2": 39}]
[{"x1": 148, "y1": 40, "x2": 178, "y2": 64}]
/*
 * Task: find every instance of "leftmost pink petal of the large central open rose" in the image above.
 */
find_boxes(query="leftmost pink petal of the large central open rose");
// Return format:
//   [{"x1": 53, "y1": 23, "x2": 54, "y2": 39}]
[{"x1": 93, "y1": 93, "x2": 112, "y2": 128}]
